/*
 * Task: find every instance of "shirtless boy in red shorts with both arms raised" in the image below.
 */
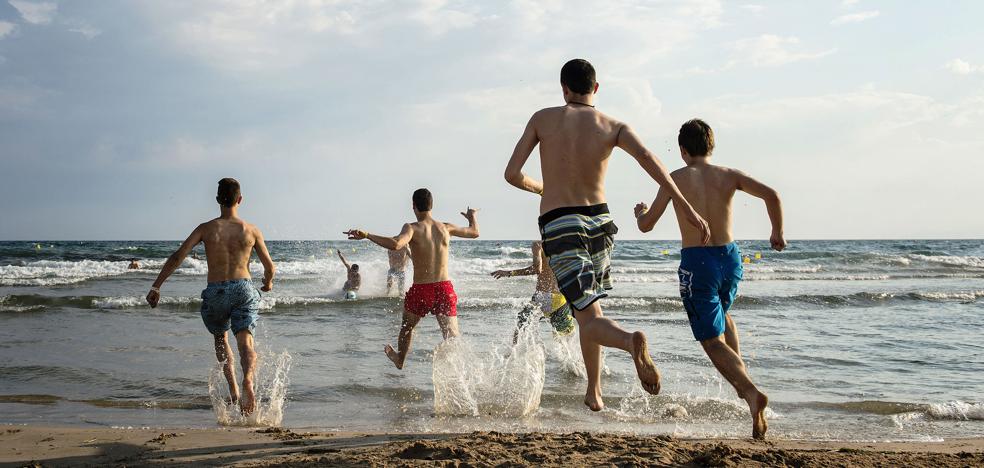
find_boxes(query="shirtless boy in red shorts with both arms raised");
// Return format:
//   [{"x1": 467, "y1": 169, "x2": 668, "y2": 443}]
[{"x1": 345, "y1": 189, "x2": 478, "y2": 369}]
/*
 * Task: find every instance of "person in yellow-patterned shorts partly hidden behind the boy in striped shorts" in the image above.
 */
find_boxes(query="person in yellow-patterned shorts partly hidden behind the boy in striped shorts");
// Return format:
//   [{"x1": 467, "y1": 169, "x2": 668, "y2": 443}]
[{"x1": 492, "y1": 241, "x2": 574, "y2": 343}]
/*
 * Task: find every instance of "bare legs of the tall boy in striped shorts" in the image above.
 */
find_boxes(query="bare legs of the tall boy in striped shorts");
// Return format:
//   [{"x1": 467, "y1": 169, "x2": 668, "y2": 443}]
[{"x1": 574, "y1": 301, "x2": 660, "y2": 411}]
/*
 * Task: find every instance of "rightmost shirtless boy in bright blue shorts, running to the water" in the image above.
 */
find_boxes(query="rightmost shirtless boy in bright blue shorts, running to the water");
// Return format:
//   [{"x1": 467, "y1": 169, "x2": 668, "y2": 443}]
[{"x1": 635, "y1": 119, "x2": 786, "y2": 439}]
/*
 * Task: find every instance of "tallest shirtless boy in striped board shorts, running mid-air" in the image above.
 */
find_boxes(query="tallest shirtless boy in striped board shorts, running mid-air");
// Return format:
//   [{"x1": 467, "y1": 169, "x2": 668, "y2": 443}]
[{"x1": 505, "y1": 59, "x2": 707, "y2": 411}]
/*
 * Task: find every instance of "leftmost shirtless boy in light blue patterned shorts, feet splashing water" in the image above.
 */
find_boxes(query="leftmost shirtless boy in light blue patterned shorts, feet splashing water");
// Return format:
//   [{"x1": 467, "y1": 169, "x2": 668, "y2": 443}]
[{"x1": 147, "y1": 178, "x2": 275, "y2": 415}]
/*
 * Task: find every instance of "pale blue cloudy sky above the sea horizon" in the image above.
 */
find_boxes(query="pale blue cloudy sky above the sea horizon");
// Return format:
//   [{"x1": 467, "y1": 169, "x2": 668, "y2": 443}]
[{"x1": 0, "y1": 0, "x2": 984, "y2": 240}]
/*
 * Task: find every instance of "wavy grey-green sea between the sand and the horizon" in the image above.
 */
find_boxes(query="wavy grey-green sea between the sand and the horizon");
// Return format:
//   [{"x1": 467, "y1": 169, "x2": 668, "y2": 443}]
[{"x1": 0, "y1": 240, "x2": 984, "y2": 441}]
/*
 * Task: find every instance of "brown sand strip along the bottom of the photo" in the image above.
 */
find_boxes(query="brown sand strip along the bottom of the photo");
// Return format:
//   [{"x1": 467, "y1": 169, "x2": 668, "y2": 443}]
[{"x1": 0, "y1": 426, "x2": 984, "y2": 467}]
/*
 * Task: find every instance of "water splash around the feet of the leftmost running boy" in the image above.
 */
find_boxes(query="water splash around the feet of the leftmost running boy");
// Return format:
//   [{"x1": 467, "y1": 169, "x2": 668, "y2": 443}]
[{"x1": 208, "y1": 349, "x2": 293, "y2": 427}]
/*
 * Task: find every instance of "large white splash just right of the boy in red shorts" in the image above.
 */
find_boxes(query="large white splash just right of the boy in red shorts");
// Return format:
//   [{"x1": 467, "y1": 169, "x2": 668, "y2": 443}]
[{"x1": 433, "y1": 327, "x2": 544, "y2": 417}]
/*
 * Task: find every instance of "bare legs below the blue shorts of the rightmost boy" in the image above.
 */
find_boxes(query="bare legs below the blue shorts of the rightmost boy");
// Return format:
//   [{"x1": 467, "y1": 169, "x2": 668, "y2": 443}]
[{"x1": 700, "y1": 335, "x2": 769, "y2": 439}]
